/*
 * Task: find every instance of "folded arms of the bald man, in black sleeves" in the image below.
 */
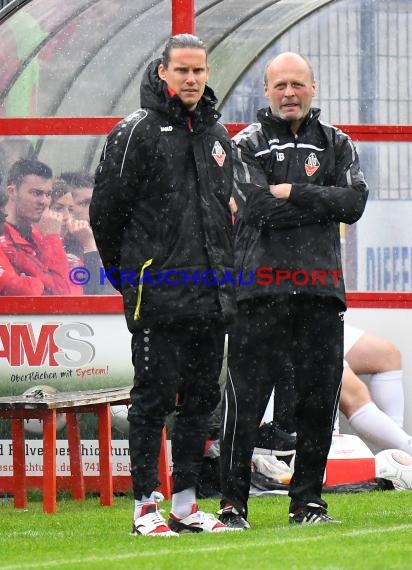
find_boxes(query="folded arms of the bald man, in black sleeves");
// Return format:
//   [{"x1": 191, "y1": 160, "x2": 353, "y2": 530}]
[{"x1": 234, "y1": 134, "x2": 368, "y2": 230}]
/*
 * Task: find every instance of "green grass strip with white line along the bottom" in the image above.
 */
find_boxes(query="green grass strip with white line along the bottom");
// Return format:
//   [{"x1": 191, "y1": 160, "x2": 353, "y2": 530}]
[{"x1": 0, "y1": 491, "x2": 412, "y2": 570}]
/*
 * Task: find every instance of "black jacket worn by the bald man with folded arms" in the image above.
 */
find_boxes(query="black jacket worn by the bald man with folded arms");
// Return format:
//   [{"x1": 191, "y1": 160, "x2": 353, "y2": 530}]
[{"x1": 234, "y1": 104, "x2": 368, "y2": 306}]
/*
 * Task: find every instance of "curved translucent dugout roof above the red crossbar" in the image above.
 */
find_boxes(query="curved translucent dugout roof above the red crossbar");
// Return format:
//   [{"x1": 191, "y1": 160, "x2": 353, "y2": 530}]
[{"x1": 0, "y1": 0, "x2": 331, "y2": 116}]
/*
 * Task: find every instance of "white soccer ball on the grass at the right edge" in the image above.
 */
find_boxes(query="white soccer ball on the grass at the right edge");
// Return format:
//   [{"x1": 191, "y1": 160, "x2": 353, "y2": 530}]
[{"x1": 375, "y1": 449, "x2": 412, "y2": 491}]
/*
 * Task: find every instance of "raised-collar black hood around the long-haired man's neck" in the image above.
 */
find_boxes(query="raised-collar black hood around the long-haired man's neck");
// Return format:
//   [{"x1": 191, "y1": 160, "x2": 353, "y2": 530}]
[{"x1": 140, "y1": 58, "x2": 220, "y2": 122}]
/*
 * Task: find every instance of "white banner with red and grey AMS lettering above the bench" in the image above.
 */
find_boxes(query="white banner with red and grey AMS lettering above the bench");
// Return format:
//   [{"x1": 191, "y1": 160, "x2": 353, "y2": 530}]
[{"x1": 0, "y1": 314, "x2": 133, "y2": 396}]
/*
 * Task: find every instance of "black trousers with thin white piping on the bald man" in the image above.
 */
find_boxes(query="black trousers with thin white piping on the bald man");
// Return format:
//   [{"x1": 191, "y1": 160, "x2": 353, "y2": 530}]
[{"x1": 221, "y1": 294, "x2": 343, "y2": 516}]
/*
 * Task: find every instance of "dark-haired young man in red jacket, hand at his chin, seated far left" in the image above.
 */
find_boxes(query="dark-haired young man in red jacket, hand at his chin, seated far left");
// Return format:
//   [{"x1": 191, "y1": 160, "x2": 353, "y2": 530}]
[{"x1": 1, "y1": 159, "x2": 70, "y2": 295}]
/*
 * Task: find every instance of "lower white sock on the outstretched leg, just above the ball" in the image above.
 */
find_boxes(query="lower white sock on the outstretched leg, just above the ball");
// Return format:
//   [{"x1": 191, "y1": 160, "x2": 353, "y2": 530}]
[{"x1": 348, "y1": 402, "x2": 412, "y2": 455}]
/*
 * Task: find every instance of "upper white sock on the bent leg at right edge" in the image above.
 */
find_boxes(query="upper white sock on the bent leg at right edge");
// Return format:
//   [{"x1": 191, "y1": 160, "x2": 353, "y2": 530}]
[{"x1": 369, "y1": 370, "x2": 404, "y2": 427}]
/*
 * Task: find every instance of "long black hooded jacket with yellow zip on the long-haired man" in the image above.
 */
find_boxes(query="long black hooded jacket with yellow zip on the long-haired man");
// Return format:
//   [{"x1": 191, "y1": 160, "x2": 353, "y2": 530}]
[{"x1": 90, "y1": 60, "x2": 235, "y2": 332}]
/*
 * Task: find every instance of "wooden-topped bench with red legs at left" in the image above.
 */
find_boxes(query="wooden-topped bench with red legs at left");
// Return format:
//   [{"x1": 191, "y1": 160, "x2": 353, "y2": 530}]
[{"x1": 0, "y1": 386, "x2": 171, "y2": 513}]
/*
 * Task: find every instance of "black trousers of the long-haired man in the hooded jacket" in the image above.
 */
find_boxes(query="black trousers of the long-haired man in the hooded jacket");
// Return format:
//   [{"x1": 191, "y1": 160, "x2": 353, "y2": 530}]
[{"x1": 128, "y1": 318, "x2": 225, "y2": 499}]
